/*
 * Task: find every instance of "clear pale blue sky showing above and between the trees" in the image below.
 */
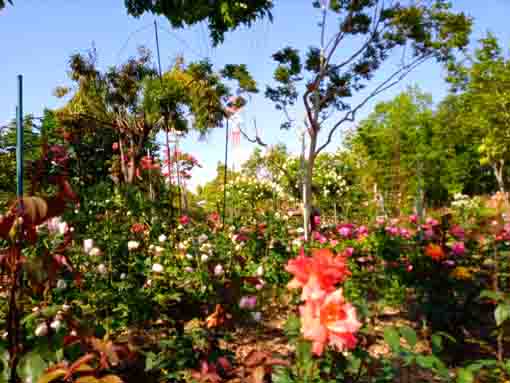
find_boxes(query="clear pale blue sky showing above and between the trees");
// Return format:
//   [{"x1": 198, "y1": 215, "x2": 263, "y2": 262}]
[{"x1": 0, "y1": 0, "x2": 510, "y2": 190}]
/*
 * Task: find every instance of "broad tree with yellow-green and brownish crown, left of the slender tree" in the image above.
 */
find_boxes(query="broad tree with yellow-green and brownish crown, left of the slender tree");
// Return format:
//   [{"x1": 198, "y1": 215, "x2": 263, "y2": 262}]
[{"x1": 56, "y1": 49, "x2": 257, "y2": 189}]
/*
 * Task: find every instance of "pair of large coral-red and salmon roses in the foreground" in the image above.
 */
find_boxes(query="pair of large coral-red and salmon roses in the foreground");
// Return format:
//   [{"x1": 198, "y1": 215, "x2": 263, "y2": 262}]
[{"x1": 286, "y1": 249, "x2": 361, "y2": 355}]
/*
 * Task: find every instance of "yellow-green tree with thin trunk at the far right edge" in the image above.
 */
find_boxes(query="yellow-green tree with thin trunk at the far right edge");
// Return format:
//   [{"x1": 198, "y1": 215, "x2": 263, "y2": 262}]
[{"x1": 448, "y1": 33, "x2": 510, "y2": 192}]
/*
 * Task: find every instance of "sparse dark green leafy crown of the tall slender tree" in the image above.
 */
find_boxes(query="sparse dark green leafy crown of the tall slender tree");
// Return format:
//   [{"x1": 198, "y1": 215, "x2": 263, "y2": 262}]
[{"x1": 266, "y1": 0, "x2": 471, "y2": 132}]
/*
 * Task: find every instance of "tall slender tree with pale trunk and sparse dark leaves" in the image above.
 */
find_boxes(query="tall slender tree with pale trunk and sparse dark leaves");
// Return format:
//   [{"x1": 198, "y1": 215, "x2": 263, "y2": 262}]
[{"x1": 266, "y1": 0, "x2": 471, "y2": 238}]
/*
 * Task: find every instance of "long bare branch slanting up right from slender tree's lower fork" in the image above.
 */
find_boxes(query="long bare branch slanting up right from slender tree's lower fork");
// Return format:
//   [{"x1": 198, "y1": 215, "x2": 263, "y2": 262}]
[{"x1": 315, "y1": 54, "x2": 432, "y2": 155}]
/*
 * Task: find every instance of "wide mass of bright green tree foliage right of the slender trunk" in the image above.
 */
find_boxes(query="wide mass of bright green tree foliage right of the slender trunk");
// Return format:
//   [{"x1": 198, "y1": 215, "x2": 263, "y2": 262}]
[{"x1": 348, "y1": 88, "x2": 495, "y2": 210}]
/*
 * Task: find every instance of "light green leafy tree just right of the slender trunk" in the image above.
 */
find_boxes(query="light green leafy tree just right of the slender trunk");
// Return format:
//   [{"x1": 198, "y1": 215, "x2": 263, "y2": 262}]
[{"x1": 350, "y1": 88, "x2": 437, "y2": 210}]
